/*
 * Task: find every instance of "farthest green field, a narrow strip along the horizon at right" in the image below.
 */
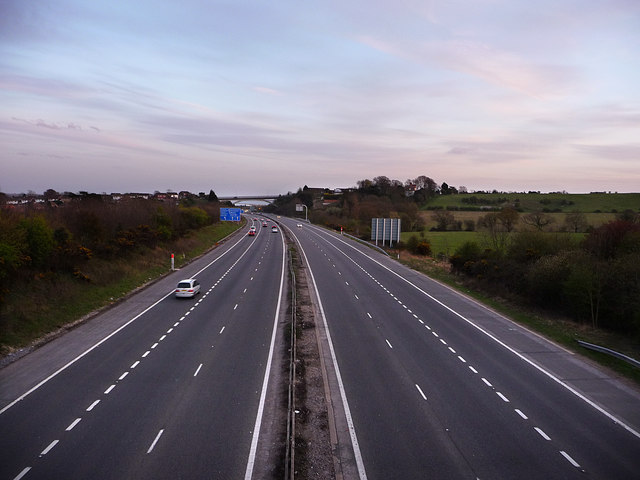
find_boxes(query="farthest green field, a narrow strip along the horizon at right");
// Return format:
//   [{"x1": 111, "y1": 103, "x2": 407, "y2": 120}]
[{"x1": 422, "y1": 193, "x2": 640, "y2": 213}]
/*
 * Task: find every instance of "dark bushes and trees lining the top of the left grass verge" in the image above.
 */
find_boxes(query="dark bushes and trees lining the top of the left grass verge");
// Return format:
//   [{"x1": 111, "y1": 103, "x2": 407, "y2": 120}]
[{"x1": 0, "y1": 192, "x2": 220, "y2": 300}]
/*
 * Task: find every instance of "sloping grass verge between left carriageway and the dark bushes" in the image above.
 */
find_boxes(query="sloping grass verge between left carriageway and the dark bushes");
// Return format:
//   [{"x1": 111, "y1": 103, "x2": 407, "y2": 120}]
[{"x1": 0, "y1": 222, "x2": 241, "y2": 356}]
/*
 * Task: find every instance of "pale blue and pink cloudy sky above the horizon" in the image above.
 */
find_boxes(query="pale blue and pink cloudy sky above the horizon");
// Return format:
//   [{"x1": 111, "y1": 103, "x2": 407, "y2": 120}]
[{"x1": 0, "y1": 0, "x2": 640, "y2": 196}]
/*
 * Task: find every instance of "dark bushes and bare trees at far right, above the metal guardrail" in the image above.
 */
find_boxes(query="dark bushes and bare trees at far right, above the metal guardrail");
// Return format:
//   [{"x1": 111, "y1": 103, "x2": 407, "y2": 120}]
[{"x1": 450, "y1": 215, "x2": 640, "y2": 335}]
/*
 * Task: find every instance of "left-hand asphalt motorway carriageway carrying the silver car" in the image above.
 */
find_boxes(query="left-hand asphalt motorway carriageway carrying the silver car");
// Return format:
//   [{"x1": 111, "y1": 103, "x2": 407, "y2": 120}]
[{"x1": 0, "y1": 219, "x2": 285, "y2": 479}]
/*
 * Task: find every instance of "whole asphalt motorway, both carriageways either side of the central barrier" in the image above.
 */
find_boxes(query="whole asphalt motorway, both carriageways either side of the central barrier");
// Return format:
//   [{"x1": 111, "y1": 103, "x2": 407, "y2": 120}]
[{"x1": 0, "y1": 218, "x2": 640, "y2": 480}]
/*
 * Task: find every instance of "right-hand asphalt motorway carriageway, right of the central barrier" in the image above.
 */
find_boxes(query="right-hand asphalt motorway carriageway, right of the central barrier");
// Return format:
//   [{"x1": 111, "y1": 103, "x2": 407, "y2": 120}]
[{"x1": 281, "y1": 219, "x2": 640, "y2": 480}]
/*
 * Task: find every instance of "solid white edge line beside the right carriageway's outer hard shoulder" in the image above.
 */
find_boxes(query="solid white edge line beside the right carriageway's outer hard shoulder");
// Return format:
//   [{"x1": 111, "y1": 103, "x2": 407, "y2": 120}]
[{"x1": 312, "y1": 229, "x2": 640, "y2": 438}]
